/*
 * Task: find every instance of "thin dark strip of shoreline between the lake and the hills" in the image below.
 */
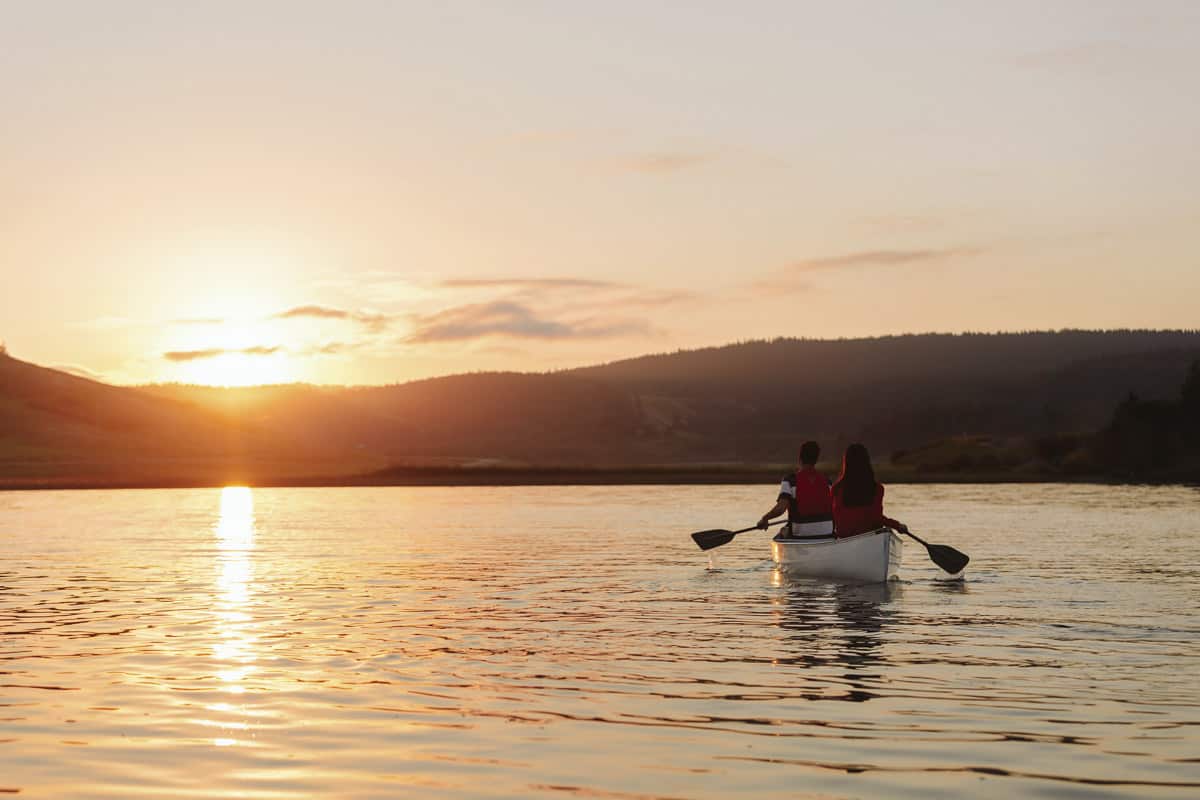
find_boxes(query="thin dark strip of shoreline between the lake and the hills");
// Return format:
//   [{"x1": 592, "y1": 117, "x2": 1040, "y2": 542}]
[{"x1": 0, "y1": 465, "x2": 1180, "y2": 491}]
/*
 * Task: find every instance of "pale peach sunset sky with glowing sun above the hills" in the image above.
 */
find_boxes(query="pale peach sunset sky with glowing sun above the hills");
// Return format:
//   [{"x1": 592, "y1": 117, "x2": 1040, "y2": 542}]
[{"x1": 0, "y1": 0, "x2": 1200, "y2": 384}]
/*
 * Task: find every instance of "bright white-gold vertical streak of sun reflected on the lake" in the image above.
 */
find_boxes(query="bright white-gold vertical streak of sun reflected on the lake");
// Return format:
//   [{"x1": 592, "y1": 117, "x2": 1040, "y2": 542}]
[{"x1": 204, "y1": 486, "x2": 258, "y2": 746}]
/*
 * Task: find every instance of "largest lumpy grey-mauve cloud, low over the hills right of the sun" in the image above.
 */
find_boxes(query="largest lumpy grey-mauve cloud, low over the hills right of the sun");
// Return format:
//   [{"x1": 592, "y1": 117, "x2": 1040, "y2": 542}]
[{"x1": 404, "y1": 301, "x2": 649, "y2": 344}]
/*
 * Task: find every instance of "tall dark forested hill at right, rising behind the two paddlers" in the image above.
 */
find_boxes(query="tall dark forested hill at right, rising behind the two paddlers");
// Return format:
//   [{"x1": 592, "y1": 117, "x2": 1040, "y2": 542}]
[{"x1": 570, "y1": 331, "x2": 1200, "y2": 461}]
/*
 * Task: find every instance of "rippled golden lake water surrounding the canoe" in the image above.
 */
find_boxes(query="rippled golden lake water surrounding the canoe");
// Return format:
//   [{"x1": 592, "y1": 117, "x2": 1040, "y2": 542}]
[{"x1": 0, "y1": 486, "x2": 1200, "y2": 798}]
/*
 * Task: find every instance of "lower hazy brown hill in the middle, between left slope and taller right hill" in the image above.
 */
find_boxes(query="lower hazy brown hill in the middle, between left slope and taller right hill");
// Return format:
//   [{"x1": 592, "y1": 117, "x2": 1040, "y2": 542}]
[{"x1": 148, "y1": 372, "x2": 640, "y2": 463}]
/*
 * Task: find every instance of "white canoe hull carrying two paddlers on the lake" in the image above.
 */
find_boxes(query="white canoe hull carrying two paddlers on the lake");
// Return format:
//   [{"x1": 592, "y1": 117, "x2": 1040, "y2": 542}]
[{"x1": 770, "y1": 525, "x2": 904, "y2": 583}]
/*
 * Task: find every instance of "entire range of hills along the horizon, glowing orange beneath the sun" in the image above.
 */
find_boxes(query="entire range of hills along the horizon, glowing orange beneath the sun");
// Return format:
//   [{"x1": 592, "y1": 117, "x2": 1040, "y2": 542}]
[{"x1": 0, "y1": 331, "x2": 1200, "y2": 482}]
